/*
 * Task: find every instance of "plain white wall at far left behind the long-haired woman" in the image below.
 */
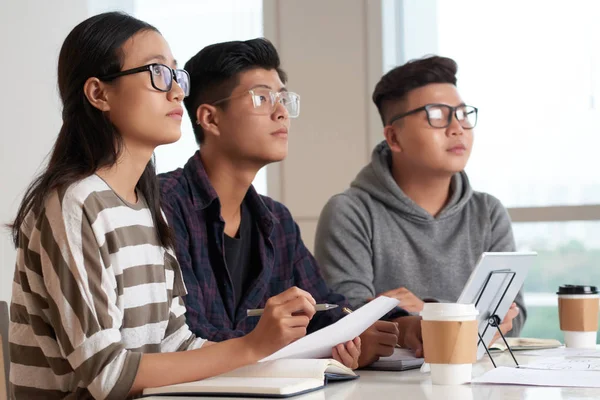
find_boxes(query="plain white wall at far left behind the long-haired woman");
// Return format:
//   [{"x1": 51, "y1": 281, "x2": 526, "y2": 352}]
[{"x1": 0, "y1": 0, "x2": 87, "y2": 301}]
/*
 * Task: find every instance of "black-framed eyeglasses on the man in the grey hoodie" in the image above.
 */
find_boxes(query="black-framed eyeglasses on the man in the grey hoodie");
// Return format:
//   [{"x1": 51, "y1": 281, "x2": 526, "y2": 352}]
[{"x1": 388, "y1": 103, "x2": 477, "y2": 129}]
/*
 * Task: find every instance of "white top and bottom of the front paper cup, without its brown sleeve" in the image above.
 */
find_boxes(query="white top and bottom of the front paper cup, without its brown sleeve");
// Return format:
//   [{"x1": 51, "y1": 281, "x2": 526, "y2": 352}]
[{"x1": 421, "y1": 303, "x2": 479, "y2": 385}]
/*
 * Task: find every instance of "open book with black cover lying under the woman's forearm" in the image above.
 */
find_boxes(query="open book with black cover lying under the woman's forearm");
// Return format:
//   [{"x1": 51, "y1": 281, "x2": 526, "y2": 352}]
[{"x1": 143, "y1": 359, "x2": 358, "y2": 397}]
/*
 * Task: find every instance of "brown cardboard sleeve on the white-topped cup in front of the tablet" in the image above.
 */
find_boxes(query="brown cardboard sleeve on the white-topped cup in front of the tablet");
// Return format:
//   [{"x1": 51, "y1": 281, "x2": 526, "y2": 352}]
[{"x1": 421, "y1": 320, "x2": 477, "y2": 364}]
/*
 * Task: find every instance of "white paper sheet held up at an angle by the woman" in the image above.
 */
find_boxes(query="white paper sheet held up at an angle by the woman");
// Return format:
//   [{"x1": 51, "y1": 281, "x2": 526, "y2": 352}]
[{"x1": 261, "y1": 296, "x2": 399, "y2": 361}]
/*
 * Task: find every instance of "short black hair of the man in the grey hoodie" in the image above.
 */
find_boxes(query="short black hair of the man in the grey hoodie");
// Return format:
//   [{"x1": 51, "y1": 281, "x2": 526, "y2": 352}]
[{"x1": 373, "y1": 56, "x2": 458, "y2": 125}]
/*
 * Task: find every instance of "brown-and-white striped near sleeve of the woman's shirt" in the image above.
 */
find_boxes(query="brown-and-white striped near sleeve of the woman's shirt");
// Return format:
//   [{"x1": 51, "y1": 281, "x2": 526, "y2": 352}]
[{"x1": 36, "y1": 193, "x2": 141, "y2": 399}]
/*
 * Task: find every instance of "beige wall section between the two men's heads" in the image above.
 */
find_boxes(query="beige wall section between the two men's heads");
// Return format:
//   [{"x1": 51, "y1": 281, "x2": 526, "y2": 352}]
[{"x1": 264, "y1": 0, "x2": 383, "y2": 249}]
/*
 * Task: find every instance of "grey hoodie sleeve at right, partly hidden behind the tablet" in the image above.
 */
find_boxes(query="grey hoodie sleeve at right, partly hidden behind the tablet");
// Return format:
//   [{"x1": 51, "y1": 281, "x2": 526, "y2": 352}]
[{"x1": 486, "y1": 196, "x2": 527, "y2": 337}]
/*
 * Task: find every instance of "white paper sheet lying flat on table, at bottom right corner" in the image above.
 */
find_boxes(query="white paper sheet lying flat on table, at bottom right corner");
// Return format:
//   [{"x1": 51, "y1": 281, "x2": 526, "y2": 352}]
[{"x1": 473, "y1": 367, "x2": 600, "y2": 388}]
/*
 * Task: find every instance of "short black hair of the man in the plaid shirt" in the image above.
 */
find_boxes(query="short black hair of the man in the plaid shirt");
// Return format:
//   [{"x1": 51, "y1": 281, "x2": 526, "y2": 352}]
[{"x1": 183, "y1": 38, "x2": 287, "y2": 144}]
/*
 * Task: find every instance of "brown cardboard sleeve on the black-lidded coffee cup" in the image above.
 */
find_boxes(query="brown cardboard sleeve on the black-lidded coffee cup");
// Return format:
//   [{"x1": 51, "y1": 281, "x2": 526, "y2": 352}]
[{"x1": 558, "y1": 297, "x2": 600, "y2": 332}]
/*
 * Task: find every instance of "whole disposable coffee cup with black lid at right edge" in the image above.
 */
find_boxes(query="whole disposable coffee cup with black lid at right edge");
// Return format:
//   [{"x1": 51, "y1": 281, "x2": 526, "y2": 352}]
[{"x1": 556, "y1": 285, "x2": 600, "y2": 349}]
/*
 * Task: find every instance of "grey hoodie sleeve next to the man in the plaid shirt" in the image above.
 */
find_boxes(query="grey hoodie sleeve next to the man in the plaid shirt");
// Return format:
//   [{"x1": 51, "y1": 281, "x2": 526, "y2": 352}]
[{"x1": 315, "y1": 194, "x2": 409, "y2": 320}]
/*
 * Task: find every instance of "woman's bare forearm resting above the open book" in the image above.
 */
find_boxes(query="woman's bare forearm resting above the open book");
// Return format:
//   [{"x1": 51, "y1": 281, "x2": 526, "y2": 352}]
[{"x1": 129, "y1": 338, "x2": 262, "y2": 395}]
